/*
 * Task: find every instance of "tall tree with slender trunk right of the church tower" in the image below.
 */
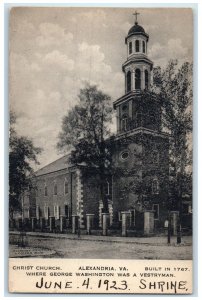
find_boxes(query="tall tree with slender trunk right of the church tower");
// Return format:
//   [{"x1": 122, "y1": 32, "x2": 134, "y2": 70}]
[{"x1": 154, "y1": 61, "x2": 193, "y2": 243}]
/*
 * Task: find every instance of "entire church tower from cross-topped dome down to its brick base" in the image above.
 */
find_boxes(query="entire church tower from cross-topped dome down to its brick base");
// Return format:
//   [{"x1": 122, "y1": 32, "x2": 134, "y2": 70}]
[{"x1": 112, "y1": 13, "x2": 169, "y2": 230}]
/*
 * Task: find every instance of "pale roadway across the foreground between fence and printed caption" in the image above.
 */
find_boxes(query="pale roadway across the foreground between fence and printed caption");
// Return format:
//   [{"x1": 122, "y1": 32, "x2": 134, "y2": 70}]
[{"x1": 10, "y1": 233, "x2": 192, "y2": 260}]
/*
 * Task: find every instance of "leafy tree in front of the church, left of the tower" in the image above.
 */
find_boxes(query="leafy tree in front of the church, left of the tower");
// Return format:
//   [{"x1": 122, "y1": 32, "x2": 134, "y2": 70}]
[{"x1": 57, "y1": 84, "x2": 112, "y2": 212}]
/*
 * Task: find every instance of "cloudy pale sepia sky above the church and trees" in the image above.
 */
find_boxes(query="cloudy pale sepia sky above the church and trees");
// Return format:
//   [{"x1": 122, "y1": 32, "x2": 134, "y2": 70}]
[{"x1": 9, "y1": 7, "x2": 193, "y2": 167}]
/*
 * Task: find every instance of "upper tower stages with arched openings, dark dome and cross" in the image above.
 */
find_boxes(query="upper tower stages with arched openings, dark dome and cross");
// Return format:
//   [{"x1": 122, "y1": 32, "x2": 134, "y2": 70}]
[{"x1": 114, "y1": 12, "x2": 161, "y2": 134}]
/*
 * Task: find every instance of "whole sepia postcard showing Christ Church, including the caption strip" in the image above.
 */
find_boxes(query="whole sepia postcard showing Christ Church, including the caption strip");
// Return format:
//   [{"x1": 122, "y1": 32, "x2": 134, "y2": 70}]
[{"x1": 8, "y1": 7, "x2": 193, "y2": 294}]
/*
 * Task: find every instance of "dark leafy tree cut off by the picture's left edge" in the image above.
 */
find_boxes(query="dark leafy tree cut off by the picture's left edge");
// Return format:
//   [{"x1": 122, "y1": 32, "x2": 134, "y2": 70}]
[{"x1": 9, "y1": 111, "x2": 42, "y2": 219}]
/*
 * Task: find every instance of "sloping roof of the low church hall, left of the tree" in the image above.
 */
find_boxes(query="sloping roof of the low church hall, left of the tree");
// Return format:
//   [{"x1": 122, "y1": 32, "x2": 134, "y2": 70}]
[{"x1": 35, "y1": 155, "x2": 70, "y2": 176}]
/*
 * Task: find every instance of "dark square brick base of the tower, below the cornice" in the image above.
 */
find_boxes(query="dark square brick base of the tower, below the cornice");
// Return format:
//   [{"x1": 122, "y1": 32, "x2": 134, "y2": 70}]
[{"x1": 113, "y1": 134, "x2": 169, "y2": 226}]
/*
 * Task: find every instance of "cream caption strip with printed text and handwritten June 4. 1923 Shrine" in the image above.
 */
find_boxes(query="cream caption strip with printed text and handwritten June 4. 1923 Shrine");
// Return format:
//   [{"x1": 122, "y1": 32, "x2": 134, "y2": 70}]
[{"x1": 9, "y1": 262, "x2": 191, "y2": 294}]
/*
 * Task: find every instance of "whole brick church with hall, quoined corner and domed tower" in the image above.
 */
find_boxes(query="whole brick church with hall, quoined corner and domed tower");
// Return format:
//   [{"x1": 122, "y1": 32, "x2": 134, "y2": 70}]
[{"x1": 20, "y1": 15, "x2": 174, "y2": 231}]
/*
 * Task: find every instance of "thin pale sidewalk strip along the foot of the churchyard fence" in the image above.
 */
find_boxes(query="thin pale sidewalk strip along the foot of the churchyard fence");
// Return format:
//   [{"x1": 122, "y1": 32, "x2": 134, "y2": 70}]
[{"x1": 9, "y1": 231, "x2": 192, "y2": 247}]
